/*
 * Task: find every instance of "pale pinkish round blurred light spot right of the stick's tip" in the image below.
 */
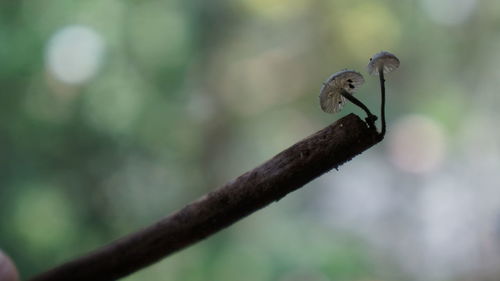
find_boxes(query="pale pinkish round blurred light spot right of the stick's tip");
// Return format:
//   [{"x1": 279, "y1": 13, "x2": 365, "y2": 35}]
[{"x1": 388, "y1": 115, "x2": 446, "y2": 174}]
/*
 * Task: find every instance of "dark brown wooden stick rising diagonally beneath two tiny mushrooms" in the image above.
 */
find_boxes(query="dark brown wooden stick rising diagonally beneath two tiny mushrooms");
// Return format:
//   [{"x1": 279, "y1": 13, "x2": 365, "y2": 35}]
[{"x1": 31, "y1": 114, "x2": 381, "y2": 281}]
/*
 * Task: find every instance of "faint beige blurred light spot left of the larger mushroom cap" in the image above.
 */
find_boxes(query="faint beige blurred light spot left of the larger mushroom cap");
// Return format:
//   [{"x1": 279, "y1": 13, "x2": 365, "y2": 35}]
[{"x1": 219, "y1": 48, "x2": 305, "y2": 115}]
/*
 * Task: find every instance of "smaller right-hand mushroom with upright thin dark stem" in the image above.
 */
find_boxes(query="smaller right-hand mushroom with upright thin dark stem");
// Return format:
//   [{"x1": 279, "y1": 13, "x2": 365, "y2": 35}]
[{"x1": 368, "y1": 51, "x2": 399, "y2": 137}]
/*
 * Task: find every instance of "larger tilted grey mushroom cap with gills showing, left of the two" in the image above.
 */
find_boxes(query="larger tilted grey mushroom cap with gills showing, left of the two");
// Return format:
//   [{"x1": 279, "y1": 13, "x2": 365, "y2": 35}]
[{"x1": 319, "y1": 69, "x2": 365, "y2": 113}]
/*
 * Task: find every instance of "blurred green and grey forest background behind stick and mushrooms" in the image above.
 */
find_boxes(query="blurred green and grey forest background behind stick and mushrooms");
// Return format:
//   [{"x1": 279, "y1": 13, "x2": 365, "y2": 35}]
[{"x1": 0, "y1": 0, "x2": 500, "y2": 281}]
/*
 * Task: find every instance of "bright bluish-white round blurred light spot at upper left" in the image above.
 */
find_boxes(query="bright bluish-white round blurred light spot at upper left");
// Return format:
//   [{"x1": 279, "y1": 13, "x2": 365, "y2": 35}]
[{"x1": 45, "y1": 25, "x2": 104, "y2": 84}]
